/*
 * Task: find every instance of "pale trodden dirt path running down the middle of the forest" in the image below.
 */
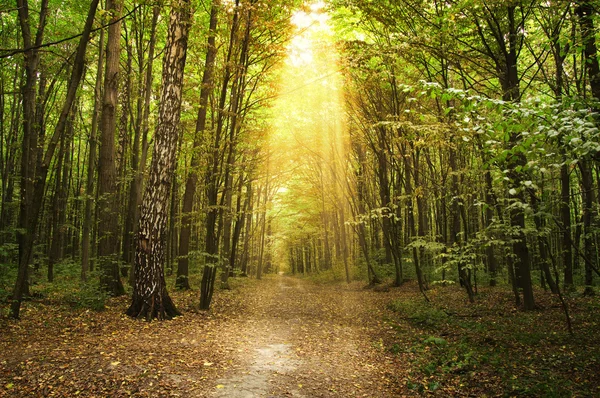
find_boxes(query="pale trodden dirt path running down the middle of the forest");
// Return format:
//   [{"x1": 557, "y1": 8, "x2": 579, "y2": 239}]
[{"x1": 209, "y1": 276, "x2": 394, "y2": 398}]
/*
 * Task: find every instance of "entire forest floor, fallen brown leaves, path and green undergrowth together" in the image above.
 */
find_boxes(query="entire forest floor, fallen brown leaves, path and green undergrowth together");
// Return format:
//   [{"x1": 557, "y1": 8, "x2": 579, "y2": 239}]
[{"x1": 0, "y1": 275, "x2": 600, "y2": 398}]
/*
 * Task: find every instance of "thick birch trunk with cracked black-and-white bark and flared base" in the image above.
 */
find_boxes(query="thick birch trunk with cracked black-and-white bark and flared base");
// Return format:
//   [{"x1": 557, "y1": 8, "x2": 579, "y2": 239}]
[{"x1": 127, "y1": 0, "x2": 191, "y2": 320}]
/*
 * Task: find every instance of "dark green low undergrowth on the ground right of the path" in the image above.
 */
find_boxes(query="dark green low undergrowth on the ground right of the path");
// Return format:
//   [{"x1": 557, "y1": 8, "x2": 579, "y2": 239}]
[{"x1": 387, "y1": 287, "x2": 600, "y2": 397}]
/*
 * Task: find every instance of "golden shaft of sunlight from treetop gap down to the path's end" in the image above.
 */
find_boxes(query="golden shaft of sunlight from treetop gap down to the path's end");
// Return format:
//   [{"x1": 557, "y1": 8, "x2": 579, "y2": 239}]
[{"x1": 268, "y1": 3, "x2": 348, "y2": 276}]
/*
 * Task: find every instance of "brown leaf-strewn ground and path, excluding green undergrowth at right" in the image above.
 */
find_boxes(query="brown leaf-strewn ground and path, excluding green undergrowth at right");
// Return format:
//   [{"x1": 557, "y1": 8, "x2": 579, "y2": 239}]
[{"x1": 0, "y1": 276, "x2": 406, "y2": 398}]
